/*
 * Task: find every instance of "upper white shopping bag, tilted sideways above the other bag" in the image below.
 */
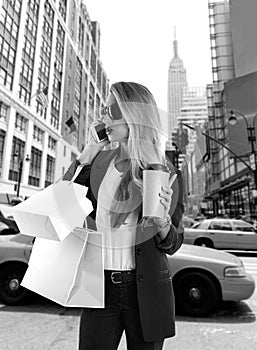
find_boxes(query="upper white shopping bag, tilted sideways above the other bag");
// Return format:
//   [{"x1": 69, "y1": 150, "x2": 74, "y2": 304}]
[{"x1": 3, "y1": 181, "x2": 93, "y2": 240}]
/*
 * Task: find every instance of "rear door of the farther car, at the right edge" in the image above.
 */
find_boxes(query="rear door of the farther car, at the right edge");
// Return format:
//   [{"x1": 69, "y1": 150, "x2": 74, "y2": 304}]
[{"x1": 232, "y1": 220, "x2": 257, "y2": 250}]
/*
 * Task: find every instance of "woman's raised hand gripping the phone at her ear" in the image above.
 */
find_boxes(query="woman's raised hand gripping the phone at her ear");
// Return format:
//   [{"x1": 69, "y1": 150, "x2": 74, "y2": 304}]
[{"x1": 78, "y1": 120, "x2": 110, "y2": 165}]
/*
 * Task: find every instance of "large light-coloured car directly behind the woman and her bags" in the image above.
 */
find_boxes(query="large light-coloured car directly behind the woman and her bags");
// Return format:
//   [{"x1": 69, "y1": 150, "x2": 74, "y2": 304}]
[{"x1": 0, "y1": 233, "x2": 255, "y2": 316}]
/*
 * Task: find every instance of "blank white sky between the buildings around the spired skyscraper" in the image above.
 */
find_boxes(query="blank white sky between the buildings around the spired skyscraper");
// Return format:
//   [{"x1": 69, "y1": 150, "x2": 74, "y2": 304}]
[{"x1": 83, "y1": 0, "x2": 212, "y2": 111}]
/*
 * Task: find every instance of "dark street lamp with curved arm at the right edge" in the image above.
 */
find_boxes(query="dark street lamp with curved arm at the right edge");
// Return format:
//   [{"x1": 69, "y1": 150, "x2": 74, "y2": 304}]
[{"x1": 228, "y1": 110, "x2": 257, "y2": 190}]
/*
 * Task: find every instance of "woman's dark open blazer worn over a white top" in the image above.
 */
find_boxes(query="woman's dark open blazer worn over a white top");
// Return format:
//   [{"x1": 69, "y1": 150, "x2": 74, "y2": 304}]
[{"x1": 63, "y1": 149, "x2": 184, "y2": 342}]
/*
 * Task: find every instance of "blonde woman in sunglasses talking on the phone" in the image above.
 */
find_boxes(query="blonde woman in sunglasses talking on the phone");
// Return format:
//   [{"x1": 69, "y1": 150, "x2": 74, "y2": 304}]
[{"x1": 64, "y1": 82, "x2": 183, "y2": 350}]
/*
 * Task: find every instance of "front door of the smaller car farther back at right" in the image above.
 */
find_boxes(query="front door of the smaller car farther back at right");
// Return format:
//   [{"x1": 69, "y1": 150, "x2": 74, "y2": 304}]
[{"x1": 208, "y1": 219, "x2": 239, "y2": 249}]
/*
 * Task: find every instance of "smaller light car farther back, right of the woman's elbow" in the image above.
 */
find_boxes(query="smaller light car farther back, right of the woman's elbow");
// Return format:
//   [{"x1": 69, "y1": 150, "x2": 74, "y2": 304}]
[{"x1": 184, "y1": 218, "x2": 257, "y2": 250}]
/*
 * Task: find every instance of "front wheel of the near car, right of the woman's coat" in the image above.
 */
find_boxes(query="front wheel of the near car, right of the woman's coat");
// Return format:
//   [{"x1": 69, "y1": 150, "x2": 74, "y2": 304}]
[{"x1": 174, "y1": 271, "x2": 219, "y2": 316}]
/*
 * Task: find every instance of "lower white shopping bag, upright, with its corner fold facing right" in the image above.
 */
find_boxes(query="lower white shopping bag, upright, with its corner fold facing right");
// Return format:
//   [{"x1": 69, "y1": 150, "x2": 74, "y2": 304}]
[{"x1": 21, "y1": 228, "x2": 104, "y2": 308}]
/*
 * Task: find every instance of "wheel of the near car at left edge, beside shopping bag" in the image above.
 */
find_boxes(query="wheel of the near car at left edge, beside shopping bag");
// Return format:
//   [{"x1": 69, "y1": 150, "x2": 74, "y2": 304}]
[{"x1": 0, "y1": 263, "x2": 29, "y2": 305}]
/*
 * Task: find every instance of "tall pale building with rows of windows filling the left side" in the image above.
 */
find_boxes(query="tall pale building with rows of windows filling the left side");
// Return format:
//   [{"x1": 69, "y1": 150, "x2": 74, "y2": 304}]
[{"x1": 0, "y1": 0, "x2": 108, "y2": 201}]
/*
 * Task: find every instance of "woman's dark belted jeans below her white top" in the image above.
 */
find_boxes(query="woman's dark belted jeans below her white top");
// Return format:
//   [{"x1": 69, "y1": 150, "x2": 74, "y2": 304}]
[{"x1": 79, "y1": 271, "x2": 163, "y2": 350}]
